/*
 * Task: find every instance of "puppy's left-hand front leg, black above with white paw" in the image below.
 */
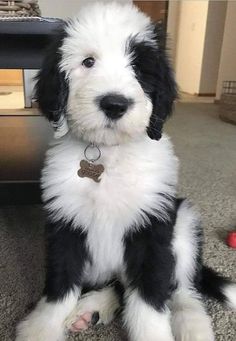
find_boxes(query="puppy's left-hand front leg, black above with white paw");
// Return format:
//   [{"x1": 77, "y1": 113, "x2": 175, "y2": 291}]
[{"x1": 16, "y1": 220, "x2": 86, "y2": 341}]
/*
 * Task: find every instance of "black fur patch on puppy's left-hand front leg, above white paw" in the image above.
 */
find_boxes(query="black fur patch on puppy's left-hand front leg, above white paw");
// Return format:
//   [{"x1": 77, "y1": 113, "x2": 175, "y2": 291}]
[{"x1": 44, "y1": 218, "x2": 88, "y2": 301}]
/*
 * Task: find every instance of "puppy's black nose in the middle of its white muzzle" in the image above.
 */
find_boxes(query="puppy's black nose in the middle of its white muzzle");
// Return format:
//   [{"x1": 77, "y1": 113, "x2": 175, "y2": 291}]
[{"x1": 100, "y1": 94, "x2": 130, "y2": 120}]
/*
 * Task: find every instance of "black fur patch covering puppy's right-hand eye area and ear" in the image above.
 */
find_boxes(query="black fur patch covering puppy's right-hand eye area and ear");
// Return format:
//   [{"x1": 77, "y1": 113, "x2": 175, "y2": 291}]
[{"x1": 127, "y1": 25, "x2": 177, "y2": 140}]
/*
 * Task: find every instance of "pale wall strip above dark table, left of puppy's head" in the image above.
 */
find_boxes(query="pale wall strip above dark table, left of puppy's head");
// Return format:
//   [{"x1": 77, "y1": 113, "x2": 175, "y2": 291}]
[{"x1": 39, "y1": 0, "x2": 131, "y2": 19}]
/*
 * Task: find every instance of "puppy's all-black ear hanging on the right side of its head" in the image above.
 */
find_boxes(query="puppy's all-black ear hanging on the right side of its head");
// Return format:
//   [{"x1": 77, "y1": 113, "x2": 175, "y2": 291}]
[{"x1": 147, "y1": 25, "x2": 178, "y2": 140}]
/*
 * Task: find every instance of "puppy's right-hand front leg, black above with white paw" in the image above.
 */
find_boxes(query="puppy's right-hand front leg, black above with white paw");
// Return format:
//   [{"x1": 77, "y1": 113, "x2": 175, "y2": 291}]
[{"x1": 124, "y1": 217, "x2": 174, "y2": 341}]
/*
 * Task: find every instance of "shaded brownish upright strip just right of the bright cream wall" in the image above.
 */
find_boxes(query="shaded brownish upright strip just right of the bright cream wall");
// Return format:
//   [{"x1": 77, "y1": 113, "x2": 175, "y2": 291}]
[{"x1": 199, "y1": 1, "x2": 227, "y2": 94}]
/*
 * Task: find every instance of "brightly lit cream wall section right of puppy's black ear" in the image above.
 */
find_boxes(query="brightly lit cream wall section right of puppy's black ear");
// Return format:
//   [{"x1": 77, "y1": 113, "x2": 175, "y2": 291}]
[{"x1": 176, "y1": 0, "x2": 208, "y2": 94}]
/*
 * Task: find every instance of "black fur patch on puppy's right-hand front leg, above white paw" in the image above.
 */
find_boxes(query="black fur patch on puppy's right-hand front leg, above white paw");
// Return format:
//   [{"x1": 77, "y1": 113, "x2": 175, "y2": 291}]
[{"x1": 124, "y1": 197, "x2": 176, "y2": 310}]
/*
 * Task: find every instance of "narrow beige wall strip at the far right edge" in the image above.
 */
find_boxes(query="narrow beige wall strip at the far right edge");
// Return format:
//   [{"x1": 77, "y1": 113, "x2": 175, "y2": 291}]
[{"x1": 216, "y1": 1, "x2": 236, "y2": 99}]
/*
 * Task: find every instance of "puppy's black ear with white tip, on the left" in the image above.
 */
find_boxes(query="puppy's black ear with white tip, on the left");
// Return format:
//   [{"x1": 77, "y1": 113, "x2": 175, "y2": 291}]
[{"x1": 35, "y1": 28, "x2": 68, "y2": 138}]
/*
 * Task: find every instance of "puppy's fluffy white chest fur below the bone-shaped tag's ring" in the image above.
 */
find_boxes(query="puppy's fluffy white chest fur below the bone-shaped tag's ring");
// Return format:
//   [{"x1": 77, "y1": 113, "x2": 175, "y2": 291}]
[{"x1": 42, "y1": 136, "x2": 177, "y2": 282}]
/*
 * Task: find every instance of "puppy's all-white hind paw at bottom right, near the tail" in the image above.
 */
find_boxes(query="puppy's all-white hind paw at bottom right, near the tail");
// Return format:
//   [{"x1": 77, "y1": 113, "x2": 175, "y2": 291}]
[{"x1": 170, "y1": 290, "x2": 214, "y2": 341}]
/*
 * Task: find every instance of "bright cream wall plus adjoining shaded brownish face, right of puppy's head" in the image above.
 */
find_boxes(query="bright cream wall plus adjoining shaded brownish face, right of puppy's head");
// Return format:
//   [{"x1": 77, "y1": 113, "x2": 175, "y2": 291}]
[{"x1": 173, "y1": 0, "x2": 227, "y2": 94}]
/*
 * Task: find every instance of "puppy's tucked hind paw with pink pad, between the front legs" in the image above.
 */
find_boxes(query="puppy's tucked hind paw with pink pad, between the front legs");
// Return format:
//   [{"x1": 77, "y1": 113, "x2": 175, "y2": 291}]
[{"x1": 66, "y1": 286, "x2": 120, "y2": 331}]
